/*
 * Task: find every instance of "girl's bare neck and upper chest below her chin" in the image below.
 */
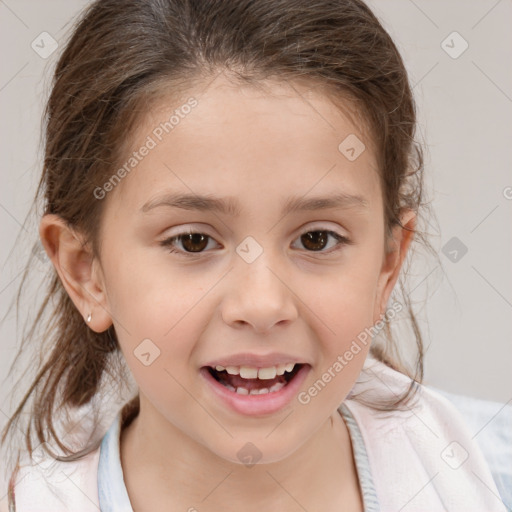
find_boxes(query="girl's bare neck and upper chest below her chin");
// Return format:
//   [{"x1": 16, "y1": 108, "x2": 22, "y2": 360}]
[{"x1": 120, "y1": 397, "x2": 362, "y2": 512}]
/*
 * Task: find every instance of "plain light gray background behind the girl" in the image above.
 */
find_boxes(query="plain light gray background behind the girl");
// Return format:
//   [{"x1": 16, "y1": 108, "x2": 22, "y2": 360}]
[{"x1": 0, "y1": 0, "x2": 512, "y2": 436}]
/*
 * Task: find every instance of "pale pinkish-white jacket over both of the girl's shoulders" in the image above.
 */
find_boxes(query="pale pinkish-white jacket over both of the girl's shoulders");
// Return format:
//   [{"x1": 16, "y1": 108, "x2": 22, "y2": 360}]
[{"x1": 3, "y1": 358, "x2": 510, "y2": 512}]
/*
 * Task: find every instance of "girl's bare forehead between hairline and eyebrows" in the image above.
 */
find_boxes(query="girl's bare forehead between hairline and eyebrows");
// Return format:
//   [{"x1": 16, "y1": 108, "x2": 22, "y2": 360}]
[{"x1": 109, "y1": 77, "x2": 380, "y2": 217}]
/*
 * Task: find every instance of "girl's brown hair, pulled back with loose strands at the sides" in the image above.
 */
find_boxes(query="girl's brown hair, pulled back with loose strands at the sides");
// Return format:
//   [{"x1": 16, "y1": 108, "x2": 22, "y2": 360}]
[{"x1": 2, "y1": 0, "x2": 440, "y2": 504}]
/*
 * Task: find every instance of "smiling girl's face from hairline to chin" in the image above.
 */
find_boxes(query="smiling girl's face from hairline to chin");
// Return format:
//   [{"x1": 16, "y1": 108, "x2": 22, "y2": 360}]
[{"x1": 90, "y1": 77, "x2": 410, "y2": 463}]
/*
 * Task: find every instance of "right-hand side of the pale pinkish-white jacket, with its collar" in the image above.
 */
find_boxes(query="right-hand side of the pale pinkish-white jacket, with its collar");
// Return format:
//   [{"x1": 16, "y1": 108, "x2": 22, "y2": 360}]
[{"x1": 345, "y1": 359, "x2": 510, "y2": 512}]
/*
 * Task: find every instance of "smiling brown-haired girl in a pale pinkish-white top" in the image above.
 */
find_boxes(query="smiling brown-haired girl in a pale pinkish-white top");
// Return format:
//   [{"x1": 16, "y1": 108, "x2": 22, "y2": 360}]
[{"x1": 2, "y1": 0, "x2": 505, "y2": 512}]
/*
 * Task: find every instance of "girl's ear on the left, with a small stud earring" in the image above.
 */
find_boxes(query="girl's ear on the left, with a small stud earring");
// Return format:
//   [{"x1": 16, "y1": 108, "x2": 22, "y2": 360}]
[{"x1": 39, "y1": 214, "x2": 112, "y2": 332}]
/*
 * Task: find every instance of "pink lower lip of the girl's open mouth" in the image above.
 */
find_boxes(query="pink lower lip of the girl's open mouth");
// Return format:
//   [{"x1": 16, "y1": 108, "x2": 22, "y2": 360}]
[{"x1": 199, "y1": 364, "x2": 311, "y2": 416}]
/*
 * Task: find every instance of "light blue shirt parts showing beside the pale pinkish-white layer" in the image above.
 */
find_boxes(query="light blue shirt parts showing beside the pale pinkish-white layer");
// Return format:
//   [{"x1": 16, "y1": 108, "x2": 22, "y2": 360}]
[{"x1": 98, "y1": 390, "x2": 512, "y2": 512}]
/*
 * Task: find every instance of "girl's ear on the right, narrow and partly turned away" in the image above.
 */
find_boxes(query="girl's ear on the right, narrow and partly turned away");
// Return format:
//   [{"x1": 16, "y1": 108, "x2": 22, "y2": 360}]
[{"x1": 373, "y1": 206, "x2": 416, "y2": 323}]
